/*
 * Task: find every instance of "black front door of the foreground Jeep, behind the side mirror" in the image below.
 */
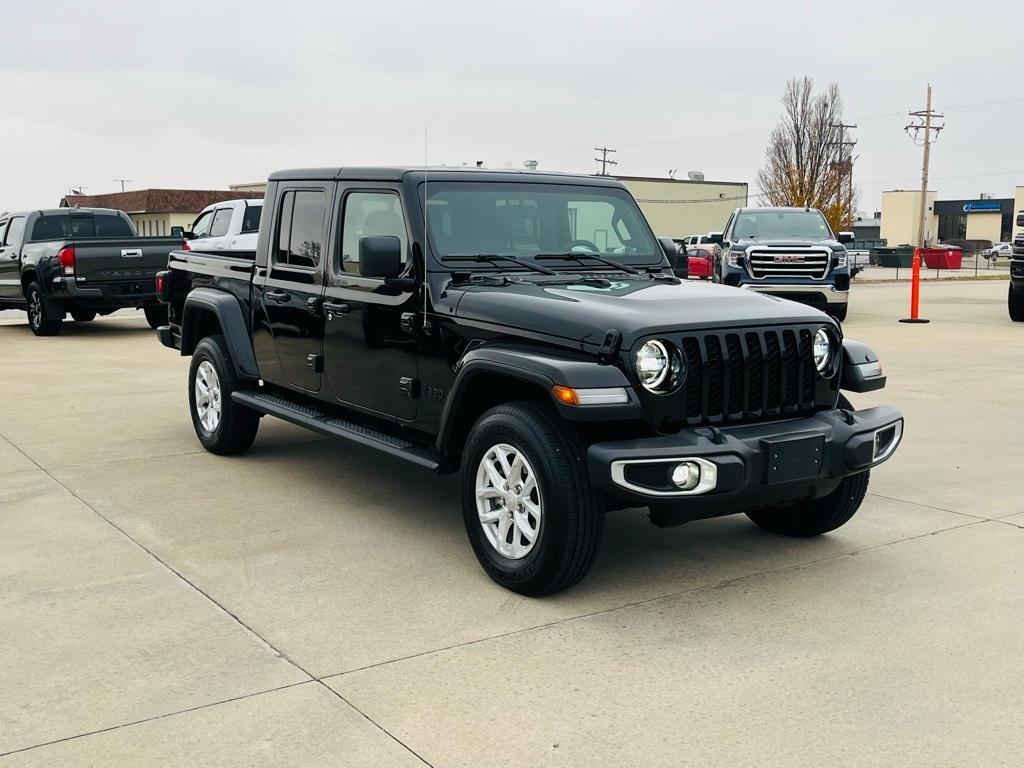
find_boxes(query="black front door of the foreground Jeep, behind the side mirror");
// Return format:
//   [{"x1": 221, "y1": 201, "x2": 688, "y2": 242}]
[{"x1": 324, "y1": 186, "x2": 415, "y2": 421}]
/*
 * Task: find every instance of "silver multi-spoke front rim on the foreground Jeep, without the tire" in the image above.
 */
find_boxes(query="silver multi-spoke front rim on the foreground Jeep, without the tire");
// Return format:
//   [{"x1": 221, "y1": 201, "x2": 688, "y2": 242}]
[{"x1": 476, "y1": 442, "x2": 544, "y2": 560}]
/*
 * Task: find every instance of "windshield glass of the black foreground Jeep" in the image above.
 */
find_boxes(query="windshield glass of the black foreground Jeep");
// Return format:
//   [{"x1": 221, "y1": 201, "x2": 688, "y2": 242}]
[{"x1": 426, "y1": 181, "x2": 664, "y2": 268}]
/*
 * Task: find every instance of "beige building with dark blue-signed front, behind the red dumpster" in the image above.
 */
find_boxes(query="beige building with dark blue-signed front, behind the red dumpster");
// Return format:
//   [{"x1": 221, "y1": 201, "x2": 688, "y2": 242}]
[{"x1": 881, "y1": 186, "x2": 1024, "y2": 246}]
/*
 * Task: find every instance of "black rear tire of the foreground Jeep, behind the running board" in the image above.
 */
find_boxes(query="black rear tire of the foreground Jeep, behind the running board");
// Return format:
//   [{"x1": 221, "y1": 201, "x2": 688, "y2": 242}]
[{"x1": 188, "y1": 336, "x2": 259, "y2": 456}]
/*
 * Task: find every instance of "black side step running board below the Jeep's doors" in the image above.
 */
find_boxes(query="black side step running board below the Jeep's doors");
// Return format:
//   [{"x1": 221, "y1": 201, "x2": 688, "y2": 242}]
[{"x1": 231, "y1": 391, "x2": 440, "y2": 472}]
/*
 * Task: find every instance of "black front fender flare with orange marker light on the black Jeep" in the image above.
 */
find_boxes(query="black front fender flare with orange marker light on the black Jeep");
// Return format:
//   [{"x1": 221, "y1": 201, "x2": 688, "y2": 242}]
[{"x1": 437, "y1": 344, "x2": 641, "y2": 451}]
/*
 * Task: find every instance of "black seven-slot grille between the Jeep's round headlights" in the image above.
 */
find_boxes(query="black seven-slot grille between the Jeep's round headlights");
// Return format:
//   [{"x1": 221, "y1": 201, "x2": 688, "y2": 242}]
[{"x1": 679, "y1": 328, "x2": 818, "y2": 426}]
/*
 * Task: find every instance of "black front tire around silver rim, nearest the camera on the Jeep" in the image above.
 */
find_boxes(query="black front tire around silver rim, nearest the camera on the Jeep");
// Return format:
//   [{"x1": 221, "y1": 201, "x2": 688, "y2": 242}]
[{"x1": 462, "y1": 402, "x2": 604, "y2": 595}]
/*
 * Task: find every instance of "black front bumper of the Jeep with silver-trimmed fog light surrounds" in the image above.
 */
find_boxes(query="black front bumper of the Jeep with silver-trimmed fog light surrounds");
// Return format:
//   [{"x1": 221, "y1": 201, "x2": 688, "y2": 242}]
[{"x1": 587, "y1": 406, "x2": 903, "y2": 525}]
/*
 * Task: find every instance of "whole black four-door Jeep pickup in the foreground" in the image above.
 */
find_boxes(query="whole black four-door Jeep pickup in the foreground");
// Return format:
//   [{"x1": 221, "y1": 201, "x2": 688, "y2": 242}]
[{"x1": 157, "y1": 168, "x2": 903, "y2": 595}]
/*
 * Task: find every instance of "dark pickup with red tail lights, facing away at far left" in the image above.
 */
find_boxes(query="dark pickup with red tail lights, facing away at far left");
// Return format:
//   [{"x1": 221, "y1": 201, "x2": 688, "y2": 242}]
[{"x1": 0, "y1": 208, "x2": 182, "y2": 336}]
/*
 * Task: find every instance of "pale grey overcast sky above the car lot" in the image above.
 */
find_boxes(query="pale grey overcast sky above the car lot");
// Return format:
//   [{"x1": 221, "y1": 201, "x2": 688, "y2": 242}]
[{"x1": 0, "y1": 0, "x2": 1024, "y2": 210}]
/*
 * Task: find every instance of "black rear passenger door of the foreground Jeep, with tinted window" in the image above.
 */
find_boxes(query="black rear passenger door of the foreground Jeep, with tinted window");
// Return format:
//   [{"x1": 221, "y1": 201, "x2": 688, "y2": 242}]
[{"x1": 254, "y1": 183, "x2": 334, "y2": 392}]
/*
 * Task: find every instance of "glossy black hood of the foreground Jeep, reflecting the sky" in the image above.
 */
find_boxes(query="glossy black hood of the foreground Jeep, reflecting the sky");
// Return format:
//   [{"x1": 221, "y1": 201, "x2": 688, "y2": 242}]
[{"x1": 456, "y1": 275, "x2": 831, "y2": 348}]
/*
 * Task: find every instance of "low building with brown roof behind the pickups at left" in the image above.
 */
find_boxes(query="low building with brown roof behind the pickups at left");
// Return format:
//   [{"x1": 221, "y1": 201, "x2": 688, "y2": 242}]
[{"x1": 60, "y1": 189, "x2": 263, "y2": 237}]
